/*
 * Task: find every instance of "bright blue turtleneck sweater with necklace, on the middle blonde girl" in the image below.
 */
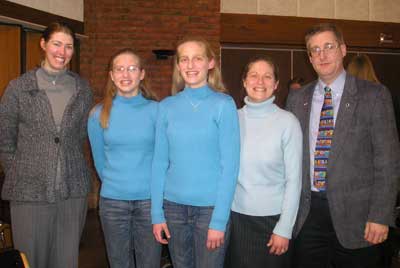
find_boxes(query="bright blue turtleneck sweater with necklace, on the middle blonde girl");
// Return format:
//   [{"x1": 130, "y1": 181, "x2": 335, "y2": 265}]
[{"x1": 151, "y1": 85, "x2": 240, "y2": 231}]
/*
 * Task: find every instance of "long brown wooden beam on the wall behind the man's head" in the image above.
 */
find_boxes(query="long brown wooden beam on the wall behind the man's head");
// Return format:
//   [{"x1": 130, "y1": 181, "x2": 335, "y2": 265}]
[{"x1": 221, "y1": 13, "x2": 400, "y2": 49}]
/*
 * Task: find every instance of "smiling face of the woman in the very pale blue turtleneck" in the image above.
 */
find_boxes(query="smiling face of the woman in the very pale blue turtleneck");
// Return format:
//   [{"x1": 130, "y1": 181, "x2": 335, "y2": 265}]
[{"x1": 243, "y1": 60, "x2": 279, "y2": 102}]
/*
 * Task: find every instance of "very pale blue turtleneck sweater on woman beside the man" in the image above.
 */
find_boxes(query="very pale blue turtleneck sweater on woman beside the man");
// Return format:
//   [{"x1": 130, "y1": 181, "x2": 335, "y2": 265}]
[{"x1": 232, "y1": 97, "x2": 303, "y2": 239}]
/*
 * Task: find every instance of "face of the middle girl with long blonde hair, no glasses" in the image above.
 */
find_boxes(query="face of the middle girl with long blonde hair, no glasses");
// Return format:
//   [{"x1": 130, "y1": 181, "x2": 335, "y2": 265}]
[{"x1": 177, "y1": 41, "x2": 215, "y2": 88}]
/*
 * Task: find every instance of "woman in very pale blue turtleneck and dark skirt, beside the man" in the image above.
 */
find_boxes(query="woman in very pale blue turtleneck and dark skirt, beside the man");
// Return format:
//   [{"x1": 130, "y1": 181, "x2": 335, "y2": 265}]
[{"x1": 227, "y1": 57, "x2": 302, "y2": 268}]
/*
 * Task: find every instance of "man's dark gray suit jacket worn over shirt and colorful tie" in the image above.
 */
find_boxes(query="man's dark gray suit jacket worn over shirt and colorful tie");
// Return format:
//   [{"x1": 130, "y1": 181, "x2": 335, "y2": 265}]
[{"x1": 287, "y1": 75, "x2": 400, "y2": 249}]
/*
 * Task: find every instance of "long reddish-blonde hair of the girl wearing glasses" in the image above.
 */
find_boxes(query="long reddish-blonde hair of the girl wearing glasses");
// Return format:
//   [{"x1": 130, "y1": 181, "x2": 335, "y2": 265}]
[{"x1": 100, "y1": 48, "x2": 158, "y2": 128}]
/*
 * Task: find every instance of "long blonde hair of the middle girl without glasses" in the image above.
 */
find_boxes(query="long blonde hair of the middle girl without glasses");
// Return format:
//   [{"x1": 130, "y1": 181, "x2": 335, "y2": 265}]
[{"x1": 172, "y1": 36, "x2": 227, "y2": 95}]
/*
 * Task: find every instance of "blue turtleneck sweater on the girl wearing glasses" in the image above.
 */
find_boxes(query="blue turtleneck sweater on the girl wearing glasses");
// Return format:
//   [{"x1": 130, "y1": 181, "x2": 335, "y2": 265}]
[{"x1": 88, "y1": 93, "x2": 158, "y2": 200}]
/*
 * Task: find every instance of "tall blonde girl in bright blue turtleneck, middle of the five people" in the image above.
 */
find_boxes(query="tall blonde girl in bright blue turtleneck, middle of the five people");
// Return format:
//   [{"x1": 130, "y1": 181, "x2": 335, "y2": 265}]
[{"x1": 151, "y1": 38, "x2": 240, "y2": 268}]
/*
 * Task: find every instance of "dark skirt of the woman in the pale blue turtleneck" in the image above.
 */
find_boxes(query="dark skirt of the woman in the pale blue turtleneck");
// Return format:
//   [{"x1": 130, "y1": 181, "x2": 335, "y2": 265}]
[{"x1": 225, "y1": 211, "x2": 291, "y2": 268}]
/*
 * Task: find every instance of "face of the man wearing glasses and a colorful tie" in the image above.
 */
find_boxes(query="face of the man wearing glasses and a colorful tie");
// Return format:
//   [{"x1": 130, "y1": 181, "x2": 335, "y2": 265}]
[{"x1": 307, "y1": 31, "x2": 346, "y2": 85}]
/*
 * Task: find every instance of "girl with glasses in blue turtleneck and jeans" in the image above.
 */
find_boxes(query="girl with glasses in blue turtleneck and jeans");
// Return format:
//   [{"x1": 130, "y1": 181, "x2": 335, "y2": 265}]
[{"x1": 88, "y1": 48, "x2": 161, "y2": 268}]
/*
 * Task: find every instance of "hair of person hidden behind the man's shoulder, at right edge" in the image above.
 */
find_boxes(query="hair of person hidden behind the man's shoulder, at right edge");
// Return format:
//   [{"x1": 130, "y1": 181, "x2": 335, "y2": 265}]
[{"x1": 347, "y1": 54, "x2": 379, "y2": 83}]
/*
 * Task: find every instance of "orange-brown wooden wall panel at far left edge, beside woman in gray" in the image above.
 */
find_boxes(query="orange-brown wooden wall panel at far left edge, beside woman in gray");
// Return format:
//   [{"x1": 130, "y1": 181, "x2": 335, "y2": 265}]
[{"x1": 0, "y1": 25, "x2": 21, "y2": 97}]
